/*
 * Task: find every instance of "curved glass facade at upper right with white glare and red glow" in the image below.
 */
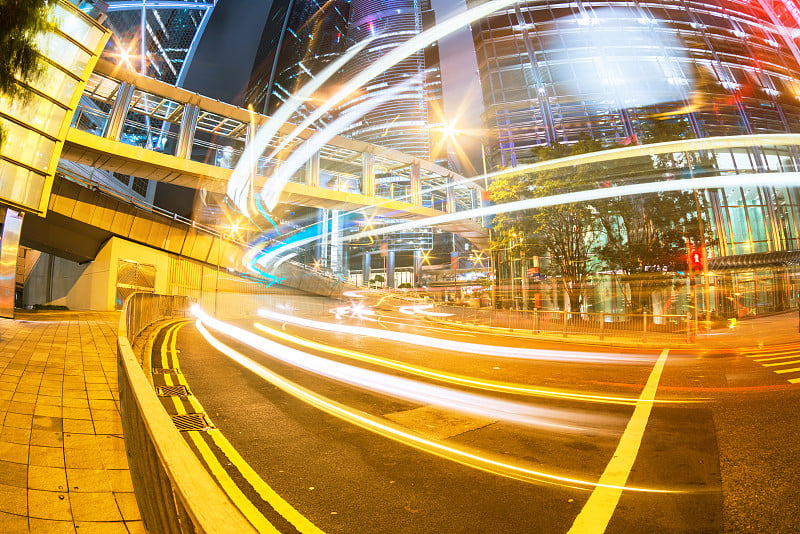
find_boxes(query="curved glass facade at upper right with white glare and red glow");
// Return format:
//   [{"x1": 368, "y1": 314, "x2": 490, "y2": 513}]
[{"x1": 468, "y1": 0, "x2": 800, "y2": 256}]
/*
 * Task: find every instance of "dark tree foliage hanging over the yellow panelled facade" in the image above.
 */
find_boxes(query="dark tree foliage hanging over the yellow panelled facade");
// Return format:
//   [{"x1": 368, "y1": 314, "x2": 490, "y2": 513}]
[{"x1": 0, "y1": 0, "x2": 55, "y2": 146}]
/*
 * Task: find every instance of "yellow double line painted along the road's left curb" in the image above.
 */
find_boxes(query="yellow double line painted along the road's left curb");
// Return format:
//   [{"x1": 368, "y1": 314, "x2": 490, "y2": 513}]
[{"x1": 161, "y1": 321, "x2": 323, "y2": 534}]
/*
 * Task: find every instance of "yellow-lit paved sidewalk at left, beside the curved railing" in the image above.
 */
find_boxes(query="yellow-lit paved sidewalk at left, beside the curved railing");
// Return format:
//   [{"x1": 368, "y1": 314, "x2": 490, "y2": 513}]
[{"x1": 0, "y1": 311, "x2": 144, "y2": 534}]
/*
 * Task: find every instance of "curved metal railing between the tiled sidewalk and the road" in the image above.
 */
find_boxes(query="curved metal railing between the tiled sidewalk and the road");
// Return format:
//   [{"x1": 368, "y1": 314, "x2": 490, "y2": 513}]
[{"x1": 117, "y1": 293, "x2": 256, "y2": 534}]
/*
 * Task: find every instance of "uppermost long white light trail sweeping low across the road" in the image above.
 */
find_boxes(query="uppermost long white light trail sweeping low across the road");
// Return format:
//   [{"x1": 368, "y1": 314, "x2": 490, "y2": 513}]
[{"x1": 258, "y1": 308, "x2": 655, "y2": 363}]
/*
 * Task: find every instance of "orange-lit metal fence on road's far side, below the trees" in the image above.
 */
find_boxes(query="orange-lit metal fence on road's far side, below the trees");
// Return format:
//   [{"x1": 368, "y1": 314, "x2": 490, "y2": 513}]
[{"x1": 436, "y1": 305, "x2": 695, "y2": 342}]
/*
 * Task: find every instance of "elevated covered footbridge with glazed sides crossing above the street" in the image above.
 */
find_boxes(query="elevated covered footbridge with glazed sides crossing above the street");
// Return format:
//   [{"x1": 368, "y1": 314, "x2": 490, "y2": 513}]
[{"x1": 61, "y1": 61, "x2": 488, "y2": 246}]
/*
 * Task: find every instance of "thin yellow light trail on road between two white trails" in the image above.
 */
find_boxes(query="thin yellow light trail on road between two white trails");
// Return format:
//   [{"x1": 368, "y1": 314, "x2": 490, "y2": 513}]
[{"x1": 254, "y1": 323, "x2": 692, "y2": 405}]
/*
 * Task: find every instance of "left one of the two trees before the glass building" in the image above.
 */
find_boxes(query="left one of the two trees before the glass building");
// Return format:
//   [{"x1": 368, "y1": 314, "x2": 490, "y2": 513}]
[{"x1": 489, "y1": 138, "x2": 602, "y2": 311}]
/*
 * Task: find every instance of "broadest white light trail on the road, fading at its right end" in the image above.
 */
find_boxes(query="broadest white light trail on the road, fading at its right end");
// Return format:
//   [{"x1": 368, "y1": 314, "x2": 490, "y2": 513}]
[{"x1": 192, "y1": 308, "x2": 622, "y2": 433}]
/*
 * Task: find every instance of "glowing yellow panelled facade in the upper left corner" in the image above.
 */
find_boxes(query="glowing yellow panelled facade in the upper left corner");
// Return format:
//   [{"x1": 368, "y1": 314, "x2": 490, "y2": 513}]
[{"x1": 0, "y1": 1, "x2": 109, "y2": 214}]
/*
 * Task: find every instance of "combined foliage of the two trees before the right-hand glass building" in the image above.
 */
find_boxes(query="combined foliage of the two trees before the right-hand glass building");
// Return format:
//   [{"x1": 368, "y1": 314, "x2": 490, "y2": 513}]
[{"x1": 490, "y1": 121, "x2": 713, "y2": 311}]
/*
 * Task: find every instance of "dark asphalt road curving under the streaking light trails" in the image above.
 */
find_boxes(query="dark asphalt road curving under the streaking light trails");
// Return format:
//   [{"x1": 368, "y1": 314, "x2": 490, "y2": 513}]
[{"x1": 153, "y1": 300, "x2": 800, "y2": 533}]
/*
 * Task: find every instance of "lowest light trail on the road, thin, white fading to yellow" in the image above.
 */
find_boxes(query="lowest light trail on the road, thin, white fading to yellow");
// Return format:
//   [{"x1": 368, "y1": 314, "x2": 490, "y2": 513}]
[{"x1": 197, "y1": 320, "x2": 680, "y2": 493}]
